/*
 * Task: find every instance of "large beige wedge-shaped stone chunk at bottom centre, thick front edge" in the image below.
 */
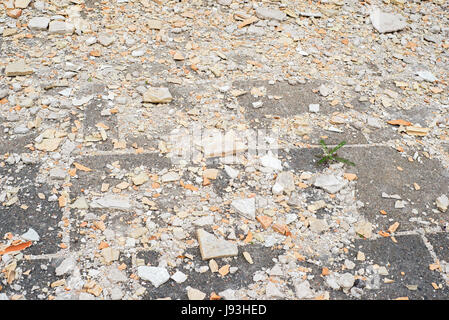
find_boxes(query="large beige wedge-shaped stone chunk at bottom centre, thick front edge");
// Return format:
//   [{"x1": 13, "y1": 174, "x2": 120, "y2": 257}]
[{"x1": 196, "y1": 229, "x2": 238, "y2": 260}]
